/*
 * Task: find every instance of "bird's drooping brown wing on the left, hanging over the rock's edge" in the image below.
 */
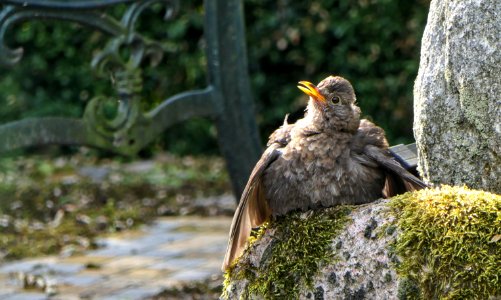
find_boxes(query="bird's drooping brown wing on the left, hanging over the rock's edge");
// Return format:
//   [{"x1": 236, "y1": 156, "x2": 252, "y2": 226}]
[{"x1": 222, "y1": 143, "x2": 282, "y2": 272}]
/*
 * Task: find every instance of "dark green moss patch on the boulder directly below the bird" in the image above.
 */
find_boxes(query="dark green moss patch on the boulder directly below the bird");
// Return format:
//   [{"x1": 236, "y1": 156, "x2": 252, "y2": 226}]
[{"x1": 223, "y1": 206, "x2": 350, "y2": 299}]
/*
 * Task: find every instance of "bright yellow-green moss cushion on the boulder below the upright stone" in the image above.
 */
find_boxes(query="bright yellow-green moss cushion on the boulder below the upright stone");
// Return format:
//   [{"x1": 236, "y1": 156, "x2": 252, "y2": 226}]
[{"x1": 390, "y1": 186, "x2": 501, "y2": 299}]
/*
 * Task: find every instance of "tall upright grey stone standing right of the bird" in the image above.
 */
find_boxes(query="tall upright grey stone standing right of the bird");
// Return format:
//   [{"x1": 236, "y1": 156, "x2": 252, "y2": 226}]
[{"x1": 414, "y1": 0, "x2": 501, "y2": 194}]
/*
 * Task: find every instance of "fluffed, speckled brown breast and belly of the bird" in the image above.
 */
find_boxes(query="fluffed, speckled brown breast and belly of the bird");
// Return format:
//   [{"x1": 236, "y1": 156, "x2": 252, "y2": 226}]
[{"x1": 263, "y1": 134, "x2": 384, "y2": 216}]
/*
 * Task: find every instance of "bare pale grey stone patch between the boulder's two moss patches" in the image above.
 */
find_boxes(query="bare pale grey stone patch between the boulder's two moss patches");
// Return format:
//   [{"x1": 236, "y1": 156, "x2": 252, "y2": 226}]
[{"x1": 312, "y1": 200, "x2": 399, "y2": 299}]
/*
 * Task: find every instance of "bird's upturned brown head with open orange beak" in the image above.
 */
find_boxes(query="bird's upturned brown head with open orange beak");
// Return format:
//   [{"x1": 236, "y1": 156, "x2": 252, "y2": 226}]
[{"x1": 297, "y1": 76, "x2": 360, "y2": 131}]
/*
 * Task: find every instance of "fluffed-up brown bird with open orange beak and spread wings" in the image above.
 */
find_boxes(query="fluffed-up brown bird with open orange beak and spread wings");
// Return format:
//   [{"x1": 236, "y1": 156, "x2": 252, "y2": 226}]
[{"x1": 222, "y1": 76, "x2": 428, "y2": 272}]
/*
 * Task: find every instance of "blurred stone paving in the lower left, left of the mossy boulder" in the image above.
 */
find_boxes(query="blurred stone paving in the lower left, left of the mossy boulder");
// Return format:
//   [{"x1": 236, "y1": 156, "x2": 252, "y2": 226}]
[{"x1": 0, "y1": 216, "x2": 231, "y2": 300}]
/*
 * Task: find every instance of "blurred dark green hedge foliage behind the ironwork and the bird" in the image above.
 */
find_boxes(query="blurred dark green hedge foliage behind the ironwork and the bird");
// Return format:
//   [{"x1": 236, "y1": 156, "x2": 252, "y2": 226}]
[{"x1": 0, "y1": 0, "x2": 429, "y2": 154}]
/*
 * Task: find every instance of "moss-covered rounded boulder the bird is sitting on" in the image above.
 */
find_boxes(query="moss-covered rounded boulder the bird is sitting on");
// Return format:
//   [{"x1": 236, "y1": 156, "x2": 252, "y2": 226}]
[{"x1": 221, "y1": 186, "x2": 501, "y2": 299}]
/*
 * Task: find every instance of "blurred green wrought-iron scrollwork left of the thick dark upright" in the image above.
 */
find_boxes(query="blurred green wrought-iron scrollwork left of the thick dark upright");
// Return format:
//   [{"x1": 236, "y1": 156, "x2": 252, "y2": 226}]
[{"x1": 0, "y1": 0, "x2": 218, "y2": 154}]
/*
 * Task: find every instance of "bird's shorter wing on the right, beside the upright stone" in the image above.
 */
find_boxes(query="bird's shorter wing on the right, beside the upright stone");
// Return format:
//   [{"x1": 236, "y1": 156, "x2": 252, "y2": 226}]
[{"x1": 363, "y1": 145, "x2": 428, "y2": 197}]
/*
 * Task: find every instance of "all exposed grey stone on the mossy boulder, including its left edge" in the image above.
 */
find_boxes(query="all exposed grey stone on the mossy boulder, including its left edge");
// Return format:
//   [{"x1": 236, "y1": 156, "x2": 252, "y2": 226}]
[{"x1": 227, "y1": 200, "x2": 400, "y2": 299}]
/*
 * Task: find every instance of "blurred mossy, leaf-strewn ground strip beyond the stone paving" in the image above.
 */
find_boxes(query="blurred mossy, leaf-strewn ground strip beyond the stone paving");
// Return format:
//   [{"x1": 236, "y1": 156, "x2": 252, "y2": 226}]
[{"x1": 0, "y1": 155, "x2": 231, "y2": 260}]
